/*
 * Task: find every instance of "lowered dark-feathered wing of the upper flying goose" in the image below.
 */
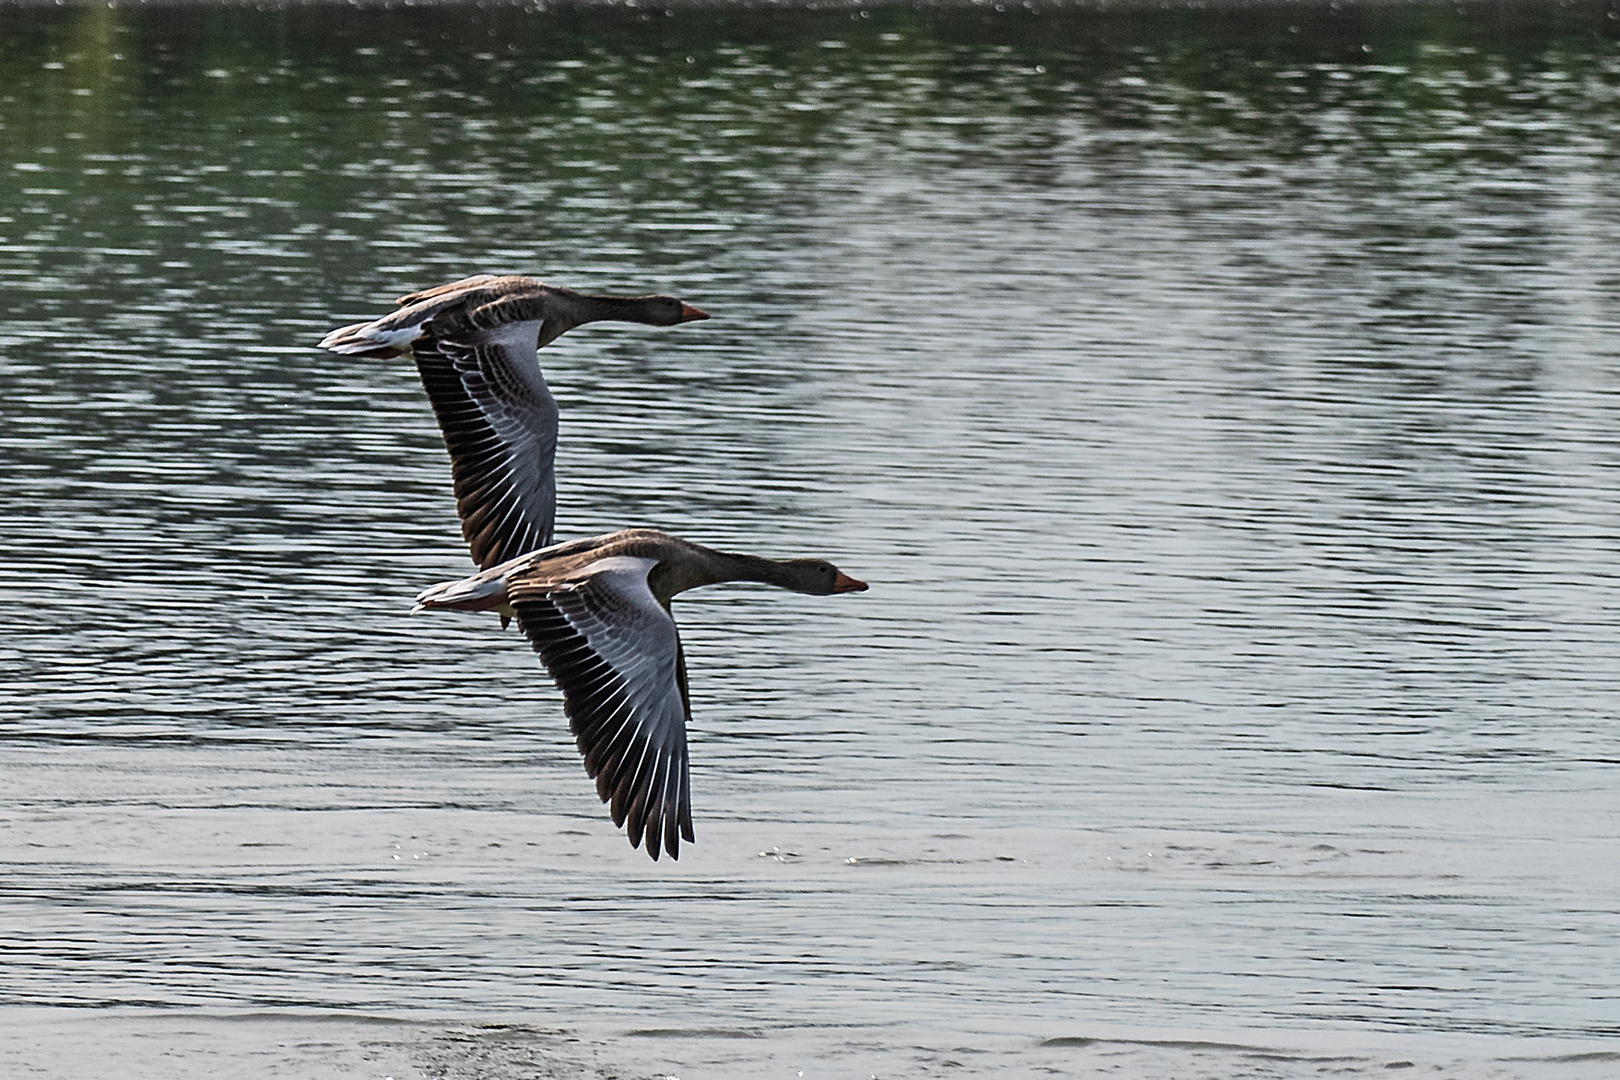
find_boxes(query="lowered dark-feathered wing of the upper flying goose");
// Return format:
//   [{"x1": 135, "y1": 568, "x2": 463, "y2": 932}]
[{"x1": 411, "y1": 319, "x2": 557, "y2": 570}]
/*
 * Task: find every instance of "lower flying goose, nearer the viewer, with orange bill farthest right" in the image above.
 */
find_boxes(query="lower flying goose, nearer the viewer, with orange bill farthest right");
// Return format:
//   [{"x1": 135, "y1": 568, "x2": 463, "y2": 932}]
[{"x1": 415, "y1": 529, "x2": 867, "y2": 860}]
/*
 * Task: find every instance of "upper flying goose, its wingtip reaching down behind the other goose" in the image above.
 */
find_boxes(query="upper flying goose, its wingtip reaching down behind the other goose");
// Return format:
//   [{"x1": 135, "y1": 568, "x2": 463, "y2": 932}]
[{"x1": 321, "y1": 274, "x2": 708, "y2": 568}]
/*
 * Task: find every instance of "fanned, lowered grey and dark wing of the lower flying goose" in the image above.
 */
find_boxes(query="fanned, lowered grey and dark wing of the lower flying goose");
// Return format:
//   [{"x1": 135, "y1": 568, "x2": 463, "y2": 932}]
[{"x1": 507, "y1": 555, "x2": 693, "y2": 860}]
